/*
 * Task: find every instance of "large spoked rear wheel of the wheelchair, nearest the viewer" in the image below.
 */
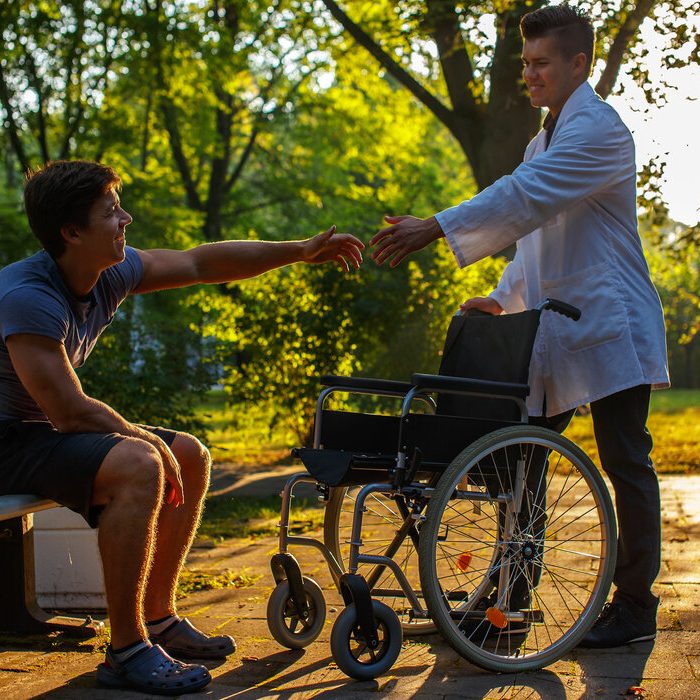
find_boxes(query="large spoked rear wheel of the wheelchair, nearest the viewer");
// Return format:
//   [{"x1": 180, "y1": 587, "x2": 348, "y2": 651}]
[{"x1": 421, "y1": 428, "x2": 614, "y2": 668}]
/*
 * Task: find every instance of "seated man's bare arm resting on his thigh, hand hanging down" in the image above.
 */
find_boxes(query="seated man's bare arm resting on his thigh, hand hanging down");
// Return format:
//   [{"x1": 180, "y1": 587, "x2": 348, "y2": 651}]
[{"x1": 5, "y1": 333, "x2": 183, "y2": 505}]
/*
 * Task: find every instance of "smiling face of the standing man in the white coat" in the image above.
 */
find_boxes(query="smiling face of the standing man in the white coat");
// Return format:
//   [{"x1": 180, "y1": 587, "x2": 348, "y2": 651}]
[{"x1": 522, "y1": 36, "x2": 586, "y2": 117}]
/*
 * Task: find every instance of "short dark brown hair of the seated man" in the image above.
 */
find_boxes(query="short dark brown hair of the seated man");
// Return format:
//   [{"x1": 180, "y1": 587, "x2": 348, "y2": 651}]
[{"x1": 24, "y1": 160, "x2": 122, "y2": 258}]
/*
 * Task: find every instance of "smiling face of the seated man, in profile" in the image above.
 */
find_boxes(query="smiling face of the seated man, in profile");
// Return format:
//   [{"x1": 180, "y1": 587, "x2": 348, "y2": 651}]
[{"x1": 79, "y1": 189, "x2": 132, "y2": 267}]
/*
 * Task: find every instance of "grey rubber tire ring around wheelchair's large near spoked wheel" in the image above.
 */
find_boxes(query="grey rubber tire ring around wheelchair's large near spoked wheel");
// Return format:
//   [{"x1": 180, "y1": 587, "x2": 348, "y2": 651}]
[{"x1": 418, "y1": 426, "x2": 617, "y2": 673}]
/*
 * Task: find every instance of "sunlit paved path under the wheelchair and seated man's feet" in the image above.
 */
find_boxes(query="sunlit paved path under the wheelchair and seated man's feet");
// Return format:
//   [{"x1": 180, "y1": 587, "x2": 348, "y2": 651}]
[{"x1": 0, "y1": 469, "x2": 700, "y2": 700}]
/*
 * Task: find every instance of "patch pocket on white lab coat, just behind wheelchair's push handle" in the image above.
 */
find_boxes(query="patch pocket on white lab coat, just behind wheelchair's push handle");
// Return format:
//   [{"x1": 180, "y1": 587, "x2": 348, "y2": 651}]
[{"x1": 542, "y1": 263, "x2": 628, "y2": 352}]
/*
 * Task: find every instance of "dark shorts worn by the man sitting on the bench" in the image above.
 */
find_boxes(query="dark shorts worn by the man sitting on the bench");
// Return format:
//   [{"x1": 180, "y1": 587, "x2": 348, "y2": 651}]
[{"x1": 0, "y1": 420, "x2": 177, "y2": 527}]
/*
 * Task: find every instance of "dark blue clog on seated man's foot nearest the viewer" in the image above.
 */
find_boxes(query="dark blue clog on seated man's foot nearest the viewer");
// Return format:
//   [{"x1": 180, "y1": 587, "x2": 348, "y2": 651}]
[{"x1": 97, "y1": 645, "x2": 211, "y2": 695}]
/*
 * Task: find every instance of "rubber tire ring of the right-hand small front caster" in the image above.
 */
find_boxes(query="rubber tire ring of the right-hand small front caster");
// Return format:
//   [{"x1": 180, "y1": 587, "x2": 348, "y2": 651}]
[{"x1": 331, "y1": 600, "x2": 403, "y2": 681}]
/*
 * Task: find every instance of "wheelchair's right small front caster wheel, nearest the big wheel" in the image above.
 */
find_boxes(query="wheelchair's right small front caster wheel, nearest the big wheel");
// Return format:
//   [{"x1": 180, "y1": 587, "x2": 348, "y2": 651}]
[{"x1": 331, "y1": 600, "x2": 402, "y2": 681}]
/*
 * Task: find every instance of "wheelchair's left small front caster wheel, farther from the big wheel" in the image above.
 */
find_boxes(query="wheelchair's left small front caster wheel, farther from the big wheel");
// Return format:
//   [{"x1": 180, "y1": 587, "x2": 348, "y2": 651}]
[{"x1": 267, "y1": 576, "x2": 326, "y2": 649}]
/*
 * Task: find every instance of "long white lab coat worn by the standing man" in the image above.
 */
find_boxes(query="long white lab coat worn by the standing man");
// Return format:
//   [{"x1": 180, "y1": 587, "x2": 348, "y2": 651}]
[{"x1": 437, "y1": 83, "x2": 669, "y2": 416}]
